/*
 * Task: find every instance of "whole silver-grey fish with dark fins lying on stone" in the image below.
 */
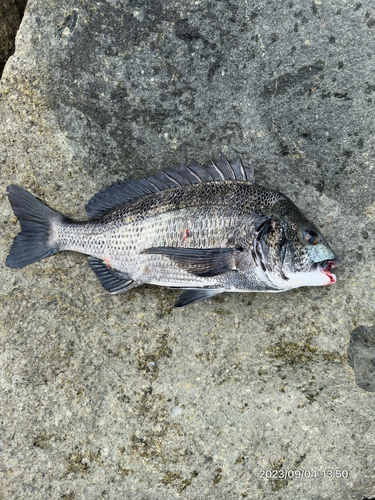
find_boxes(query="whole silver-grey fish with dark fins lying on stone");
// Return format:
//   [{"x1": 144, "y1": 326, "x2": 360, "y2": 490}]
[{"x1": 6, "y1": 154, "x2": 341, "y2": 307}]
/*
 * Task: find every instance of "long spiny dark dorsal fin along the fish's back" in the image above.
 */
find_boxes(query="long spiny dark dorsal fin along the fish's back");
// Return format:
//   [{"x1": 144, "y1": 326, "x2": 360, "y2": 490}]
[{"x1": 86, "y1": 154, "x2": 255, "y2": 218}]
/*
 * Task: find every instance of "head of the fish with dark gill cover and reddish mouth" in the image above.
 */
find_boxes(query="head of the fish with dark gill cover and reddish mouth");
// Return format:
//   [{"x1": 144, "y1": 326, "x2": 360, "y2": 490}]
[{"x1": 256, "y1": 198, "x2": 341, "y2": 290}]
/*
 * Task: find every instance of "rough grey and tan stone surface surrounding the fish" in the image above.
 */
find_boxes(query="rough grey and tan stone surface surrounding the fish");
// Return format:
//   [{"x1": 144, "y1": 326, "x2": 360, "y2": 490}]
[{"x1": 0, "y1": 0, "x2": 375, "y2": 500}]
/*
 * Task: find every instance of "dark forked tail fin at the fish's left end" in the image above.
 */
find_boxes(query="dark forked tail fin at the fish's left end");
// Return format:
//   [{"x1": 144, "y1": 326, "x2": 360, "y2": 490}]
[{"x1": 5, "y1": 185, "x2": 66, "y2": 267}]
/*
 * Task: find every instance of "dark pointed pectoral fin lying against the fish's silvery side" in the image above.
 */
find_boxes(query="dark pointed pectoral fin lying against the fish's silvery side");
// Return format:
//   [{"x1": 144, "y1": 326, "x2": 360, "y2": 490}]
[{"x1": 142, "y1": 247, "x2": 241, "y2": 278}]
